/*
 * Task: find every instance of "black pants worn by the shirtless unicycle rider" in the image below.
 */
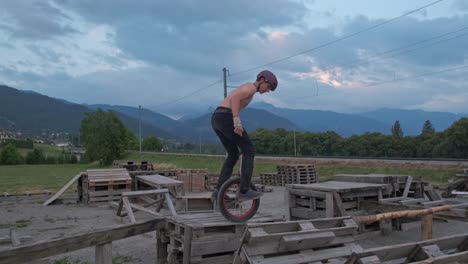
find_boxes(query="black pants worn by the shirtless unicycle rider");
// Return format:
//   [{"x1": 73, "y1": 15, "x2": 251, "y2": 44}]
[{"x1": 211, "y1": 107, "x2": 255, "y2": 192}]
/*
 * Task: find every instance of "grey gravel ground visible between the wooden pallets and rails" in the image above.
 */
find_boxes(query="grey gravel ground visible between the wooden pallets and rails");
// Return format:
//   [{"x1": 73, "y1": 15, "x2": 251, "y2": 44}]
[{"x1": 0, "y1": 187, "x2": 468, "y2": 264}]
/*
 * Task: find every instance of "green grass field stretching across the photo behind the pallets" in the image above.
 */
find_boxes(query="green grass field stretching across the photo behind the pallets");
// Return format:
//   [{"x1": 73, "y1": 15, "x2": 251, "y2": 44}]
[{"x1": 0, "y1": 153, "x2": 461, "y2": 193}]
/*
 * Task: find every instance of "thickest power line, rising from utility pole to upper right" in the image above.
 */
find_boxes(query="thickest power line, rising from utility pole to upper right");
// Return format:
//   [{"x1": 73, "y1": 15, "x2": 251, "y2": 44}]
[{"x1": 230, "y1": 0, "x2": 444, "y2": 76}]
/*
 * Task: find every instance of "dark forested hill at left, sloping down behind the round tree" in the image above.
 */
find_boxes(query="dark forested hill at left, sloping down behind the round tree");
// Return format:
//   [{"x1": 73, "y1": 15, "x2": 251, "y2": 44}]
[{"x1": 0, "y1": 85, "x2": 172, "y2": 138}]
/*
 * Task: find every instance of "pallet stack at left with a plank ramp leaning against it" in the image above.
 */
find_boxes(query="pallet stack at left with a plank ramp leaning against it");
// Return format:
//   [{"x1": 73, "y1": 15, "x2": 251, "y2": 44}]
[{"x1": 78, "y1": 169, "x2": 132, "y2": 203}]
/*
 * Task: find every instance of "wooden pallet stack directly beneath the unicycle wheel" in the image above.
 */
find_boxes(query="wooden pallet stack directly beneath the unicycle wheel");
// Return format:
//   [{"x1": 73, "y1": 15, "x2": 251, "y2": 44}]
[{"x1": 163, "y1": 213, "x2": 279, "y2": 264}]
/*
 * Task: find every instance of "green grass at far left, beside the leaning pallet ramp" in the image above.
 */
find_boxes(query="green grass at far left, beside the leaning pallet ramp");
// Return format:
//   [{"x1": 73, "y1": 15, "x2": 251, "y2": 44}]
[{"x1": 0, "y1": 164, "x2": 102, "y2": 193}]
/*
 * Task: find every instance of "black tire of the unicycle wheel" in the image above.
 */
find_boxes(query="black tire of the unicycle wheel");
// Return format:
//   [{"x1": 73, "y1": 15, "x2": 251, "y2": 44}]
[{"x1": 217, "y1": 177, "x2": 260, "y2": 223}]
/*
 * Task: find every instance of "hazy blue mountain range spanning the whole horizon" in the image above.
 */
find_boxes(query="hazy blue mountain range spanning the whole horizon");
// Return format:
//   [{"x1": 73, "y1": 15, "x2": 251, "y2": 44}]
[{"x1": 0, "y1": 85, "x2": 467, "y2": 143}]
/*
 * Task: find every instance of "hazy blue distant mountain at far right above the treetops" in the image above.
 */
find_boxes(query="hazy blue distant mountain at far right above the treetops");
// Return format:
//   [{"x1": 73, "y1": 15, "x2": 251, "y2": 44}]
[{"x1": 360, "y1": 108, "x2": 468, "y2": 136}]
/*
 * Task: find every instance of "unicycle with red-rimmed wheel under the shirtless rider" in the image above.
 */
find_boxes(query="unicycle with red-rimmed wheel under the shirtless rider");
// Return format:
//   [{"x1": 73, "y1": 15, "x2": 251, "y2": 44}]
[{"x1": 217, "y1": 177, "x2": 260, "y2": 223}]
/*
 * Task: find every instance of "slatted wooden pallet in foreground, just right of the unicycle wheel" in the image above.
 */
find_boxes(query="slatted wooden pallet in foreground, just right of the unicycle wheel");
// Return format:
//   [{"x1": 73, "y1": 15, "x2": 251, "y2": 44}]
[{"x1": 234, "y1": 217, "x2": 362, "y2": 264}]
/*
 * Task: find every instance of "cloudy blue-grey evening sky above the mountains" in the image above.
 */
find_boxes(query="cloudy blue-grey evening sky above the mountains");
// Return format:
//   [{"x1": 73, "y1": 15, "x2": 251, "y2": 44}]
[{"x1": 0, "y1": 0, "x2": 468, "y2": 117}]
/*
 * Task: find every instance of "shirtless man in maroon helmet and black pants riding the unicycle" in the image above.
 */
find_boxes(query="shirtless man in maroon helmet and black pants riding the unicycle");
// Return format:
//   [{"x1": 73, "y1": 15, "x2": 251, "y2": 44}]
[{"x1": 211, "y1": 71, "x2": 278, "y2": 201}]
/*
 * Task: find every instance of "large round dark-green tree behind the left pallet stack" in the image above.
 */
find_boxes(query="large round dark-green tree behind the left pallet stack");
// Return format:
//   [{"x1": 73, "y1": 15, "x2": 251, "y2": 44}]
[{"x1": 80, "y1": 109, "x2": 129, "y2": 164}]
